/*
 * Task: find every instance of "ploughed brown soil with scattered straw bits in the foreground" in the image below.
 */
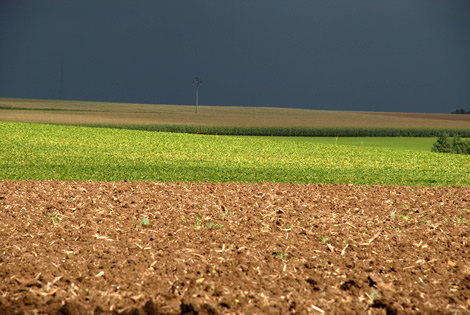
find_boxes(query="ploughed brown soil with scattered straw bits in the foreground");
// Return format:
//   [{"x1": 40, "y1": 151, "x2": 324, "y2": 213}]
[{"x1": 0, "y1": 181, "x2": 470, "y2": 314}]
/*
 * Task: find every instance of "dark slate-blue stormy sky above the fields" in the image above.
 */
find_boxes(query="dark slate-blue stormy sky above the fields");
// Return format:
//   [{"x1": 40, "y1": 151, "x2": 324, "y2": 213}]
[{"x1": 0, "y1": 0, "x2": 470, "y2": 113}]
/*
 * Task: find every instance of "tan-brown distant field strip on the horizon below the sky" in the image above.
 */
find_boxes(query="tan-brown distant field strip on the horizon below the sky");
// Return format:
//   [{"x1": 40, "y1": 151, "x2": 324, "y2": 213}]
[{"x1": 0, "y1": 98, "x2": 470, "y2": 129}]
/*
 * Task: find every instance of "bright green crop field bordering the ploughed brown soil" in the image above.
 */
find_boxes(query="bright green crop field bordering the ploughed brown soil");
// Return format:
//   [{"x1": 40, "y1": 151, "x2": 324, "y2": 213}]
[{"x1": 0, "y1": 122, "x2": 470, "y2": 186}]
